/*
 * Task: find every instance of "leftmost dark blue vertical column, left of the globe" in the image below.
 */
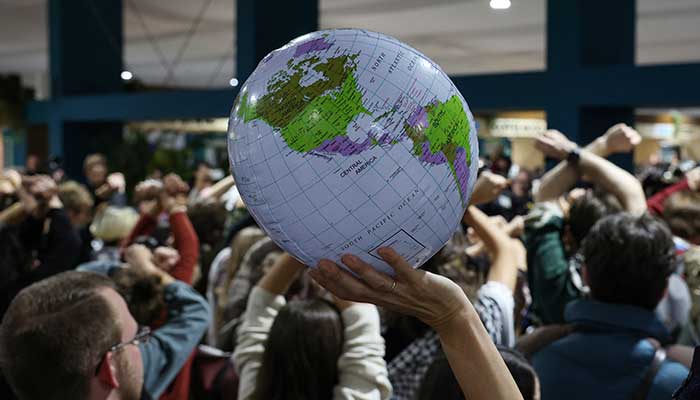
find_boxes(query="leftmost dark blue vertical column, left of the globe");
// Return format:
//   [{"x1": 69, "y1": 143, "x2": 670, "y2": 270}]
[{"x1": 47, "y1": 0, "x2": 124, "y2": 176}]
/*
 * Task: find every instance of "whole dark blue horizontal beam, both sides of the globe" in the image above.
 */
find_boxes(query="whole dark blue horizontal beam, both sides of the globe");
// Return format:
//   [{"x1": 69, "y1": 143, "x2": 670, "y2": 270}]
[{"x1": 27, "y1": 64, "x2": 700, "y2": 124}]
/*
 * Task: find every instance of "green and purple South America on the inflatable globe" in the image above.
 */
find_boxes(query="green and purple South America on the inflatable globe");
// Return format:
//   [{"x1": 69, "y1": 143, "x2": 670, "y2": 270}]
[{"x1": 404, "y1": 95, "x2": 471, "y2": 201}]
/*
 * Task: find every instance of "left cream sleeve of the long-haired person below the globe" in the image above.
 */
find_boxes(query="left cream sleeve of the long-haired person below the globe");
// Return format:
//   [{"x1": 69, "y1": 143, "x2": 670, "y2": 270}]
[{"x1": 233, "y1": 286, "x2": 286, "y2": 400}]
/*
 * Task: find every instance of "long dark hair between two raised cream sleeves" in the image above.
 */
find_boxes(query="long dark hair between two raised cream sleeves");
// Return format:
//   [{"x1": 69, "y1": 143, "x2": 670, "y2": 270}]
[{"x1": 254, "y1": 299, "x2": 344, "y2": 400}]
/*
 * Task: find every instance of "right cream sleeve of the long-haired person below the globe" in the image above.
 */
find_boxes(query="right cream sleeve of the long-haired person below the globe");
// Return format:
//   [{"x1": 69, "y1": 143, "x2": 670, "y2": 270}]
[{"x1": 333, "y1": 304, "x2": 391, "y2": 400}]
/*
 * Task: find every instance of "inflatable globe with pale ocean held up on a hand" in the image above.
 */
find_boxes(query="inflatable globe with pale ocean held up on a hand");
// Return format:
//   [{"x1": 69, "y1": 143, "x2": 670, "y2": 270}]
[{"x1": 228, "y1": 29, "x2": 478, "y2": 273}]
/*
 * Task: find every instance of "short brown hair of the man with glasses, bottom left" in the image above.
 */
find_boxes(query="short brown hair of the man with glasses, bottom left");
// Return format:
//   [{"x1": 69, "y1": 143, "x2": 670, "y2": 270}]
[{"x1": 0, "y1": 271, "x2": 121, "y2": 400}]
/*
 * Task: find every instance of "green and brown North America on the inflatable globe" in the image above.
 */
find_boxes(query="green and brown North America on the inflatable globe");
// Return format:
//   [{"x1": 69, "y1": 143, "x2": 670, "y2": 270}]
[{"x1": 237, "y1": 54, "x2": 369, "y2": 153}]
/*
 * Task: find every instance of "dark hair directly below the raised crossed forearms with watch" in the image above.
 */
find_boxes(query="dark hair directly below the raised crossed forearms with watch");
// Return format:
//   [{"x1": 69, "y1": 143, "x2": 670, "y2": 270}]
[{"x1": 568, "y1": 189, "x2": 622, "y2": 245}]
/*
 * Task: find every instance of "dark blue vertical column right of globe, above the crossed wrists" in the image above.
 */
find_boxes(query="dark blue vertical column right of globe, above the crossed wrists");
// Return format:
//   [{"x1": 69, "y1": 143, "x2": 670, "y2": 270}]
[{"x1": 545, "y1": 0, "x2": 637, "y2": 169}]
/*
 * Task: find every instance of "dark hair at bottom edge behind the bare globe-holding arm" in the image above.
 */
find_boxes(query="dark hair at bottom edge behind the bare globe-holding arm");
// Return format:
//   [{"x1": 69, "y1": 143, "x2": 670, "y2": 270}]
[{"x1": 416, "y1": 346, "x2": 538, "y2": 400}]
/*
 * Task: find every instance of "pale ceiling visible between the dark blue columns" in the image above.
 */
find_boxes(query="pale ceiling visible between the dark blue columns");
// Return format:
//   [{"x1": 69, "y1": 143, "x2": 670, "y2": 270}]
[{"x1": 0, "y1": 0, "x2": 700, "y2": 96}]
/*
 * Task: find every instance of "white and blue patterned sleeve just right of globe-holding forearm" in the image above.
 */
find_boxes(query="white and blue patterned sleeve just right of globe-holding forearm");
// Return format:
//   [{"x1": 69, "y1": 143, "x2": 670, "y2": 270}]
[{"x1": 474, "y1": 281, "x2": 515, "y2": 347}]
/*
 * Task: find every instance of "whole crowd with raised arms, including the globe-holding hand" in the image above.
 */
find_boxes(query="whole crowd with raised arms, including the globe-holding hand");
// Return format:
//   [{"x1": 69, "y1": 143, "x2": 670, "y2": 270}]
[{"x1": 0, "y1": 124, "x2": 700, "y2": 400}]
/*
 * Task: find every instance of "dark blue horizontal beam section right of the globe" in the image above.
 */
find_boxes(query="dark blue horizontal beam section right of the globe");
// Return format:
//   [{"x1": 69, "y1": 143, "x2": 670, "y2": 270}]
[{"x1": 452, "y1": 63, "x2": 700, "y2": 110}]
